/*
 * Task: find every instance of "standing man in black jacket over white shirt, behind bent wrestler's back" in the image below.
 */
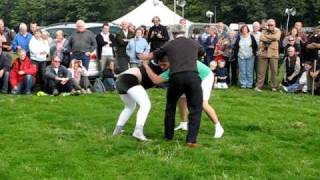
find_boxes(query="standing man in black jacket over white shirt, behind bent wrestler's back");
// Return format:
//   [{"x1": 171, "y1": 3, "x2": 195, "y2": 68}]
[{"x1": 116, "y1": 21, "x2": 134, "y2": 72}]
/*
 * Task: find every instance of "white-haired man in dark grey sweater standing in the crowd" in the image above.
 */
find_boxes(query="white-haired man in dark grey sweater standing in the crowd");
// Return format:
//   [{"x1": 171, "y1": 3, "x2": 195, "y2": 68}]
[{"x1": 69, "y1": 20, "x2": 97, "y2": 69}]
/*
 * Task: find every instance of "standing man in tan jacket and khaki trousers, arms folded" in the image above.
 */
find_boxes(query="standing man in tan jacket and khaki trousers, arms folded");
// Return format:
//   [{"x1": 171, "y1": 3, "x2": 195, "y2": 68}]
[{"x1": 255, "y1": 19, "x2": 281, "y2": 92}]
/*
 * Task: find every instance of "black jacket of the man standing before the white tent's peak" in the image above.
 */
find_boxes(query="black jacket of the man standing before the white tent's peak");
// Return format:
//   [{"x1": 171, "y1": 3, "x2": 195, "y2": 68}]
[{"x1": 148, "y1": 24, "x2": 169, "y2": 51}]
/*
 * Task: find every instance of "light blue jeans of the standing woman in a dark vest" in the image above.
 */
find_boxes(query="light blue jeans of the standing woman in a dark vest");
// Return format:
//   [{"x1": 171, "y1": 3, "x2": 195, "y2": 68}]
[{"x1": 238, "y1": 56, "x2": 254, "y2": 88}]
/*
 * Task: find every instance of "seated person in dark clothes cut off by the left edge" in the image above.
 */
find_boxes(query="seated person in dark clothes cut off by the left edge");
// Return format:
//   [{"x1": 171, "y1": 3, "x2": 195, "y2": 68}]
[{"x1": 0, "y1": 41, "x2": 10, "y2": 94}]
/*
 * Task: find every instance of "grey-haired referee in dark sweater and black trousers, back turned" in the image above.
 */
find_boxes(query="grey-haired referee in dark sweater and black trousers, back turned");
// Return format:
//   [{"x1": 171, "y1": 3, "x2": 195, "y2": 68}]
[{"x1": 140, "y1": 26, "x2": 202, "y2": 147}]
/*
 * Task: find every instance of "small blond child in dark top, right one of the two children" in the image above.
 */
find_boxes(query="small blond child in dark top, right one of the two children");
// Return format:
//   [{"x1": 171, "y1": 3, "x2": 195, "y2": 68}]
[{"x1": 215, "y1": 61, "x2": 228, "y2": 89}]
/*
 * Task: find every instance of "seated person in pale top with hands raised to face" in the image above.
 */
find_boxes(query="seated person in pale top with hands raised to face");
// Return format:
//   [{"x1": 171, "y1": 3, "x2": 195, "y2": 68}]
[{"x1": 68, "y1": 59, "x2": 92, "y2": 94}]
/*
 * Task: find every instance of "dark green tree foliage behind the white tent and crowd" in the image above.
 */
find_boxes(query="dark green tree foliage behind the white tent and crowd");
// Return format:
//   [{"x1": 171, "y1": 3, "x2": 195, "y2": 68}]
[{"x1": 0, "y1": 0, "x2": 320, "y2": 27}]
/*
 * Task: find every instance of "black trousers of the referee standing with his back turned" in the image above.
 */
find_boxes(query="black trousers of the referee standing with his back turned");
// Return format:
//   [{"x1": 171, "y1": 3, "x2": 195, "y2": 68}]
[{"x1": 165, "y1": 72, "x2": 202, "y2": 143}]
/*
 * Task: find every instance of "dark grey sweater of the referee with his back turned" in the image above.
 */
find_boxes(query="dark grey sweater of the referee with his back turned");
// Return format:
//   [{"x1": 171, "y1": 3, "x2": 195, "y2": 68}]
[{"x1": 154, "y1": 37, "x2": 201, "y2": 75}]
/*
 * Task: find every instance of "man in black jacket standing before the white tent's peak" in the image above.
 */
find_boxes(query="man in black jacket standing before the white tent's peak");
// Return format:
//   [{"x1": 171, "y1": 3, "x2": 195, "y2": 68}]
[{"x1": 148, "y1": 16, "x2": 169, "y2": 51}]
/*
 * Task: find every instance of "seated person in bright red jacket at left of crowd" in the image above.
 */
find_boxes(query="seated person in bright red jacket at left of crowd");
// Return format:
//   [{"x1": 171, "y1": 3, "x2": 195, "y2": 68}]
[{"x1": 9, "y1": 48, "x2": 37, "y2": 95}]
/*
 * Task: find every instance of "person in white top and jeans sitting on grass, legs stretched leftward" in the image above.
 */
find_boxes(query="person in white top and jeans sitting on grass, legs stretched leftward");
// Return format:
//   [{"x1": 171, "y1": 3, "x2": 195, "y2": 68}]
[{"x1": 282, "y1": 61, "x2": 312, "y2": 93}]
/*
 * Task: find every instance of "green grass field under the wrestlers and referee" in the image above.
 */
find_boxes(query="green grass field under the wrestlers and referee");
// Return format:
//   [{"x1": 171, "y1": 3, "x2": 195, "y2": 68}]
[{"x1": 0, "y1": 89, "x2": 320, "y2": 180}]
